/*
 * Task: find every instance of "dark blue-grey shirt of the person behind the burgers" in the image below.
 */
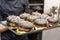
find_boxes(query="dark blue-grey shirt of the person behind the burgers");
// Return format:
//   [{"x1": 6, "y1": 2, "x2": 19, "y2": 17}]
[{"x1": 0, "y1": 0, "x2": 30, "y2": 18}]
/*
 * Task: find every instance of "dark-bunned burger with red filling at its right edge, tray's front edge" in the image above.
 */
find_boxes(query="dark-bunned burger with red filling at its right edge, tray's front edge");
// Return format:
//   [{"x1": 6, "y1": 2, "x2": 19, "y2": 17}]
[{"x1": 35, "y1": 19, "x2": 48, "y2": 30}]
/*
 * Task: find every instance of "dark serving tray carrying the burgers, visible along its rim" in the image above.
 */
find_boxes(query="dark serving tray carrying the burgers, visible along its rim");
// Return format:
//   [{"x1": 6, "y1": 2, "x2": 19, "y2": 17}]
[{"x1": 1, "y1": 21, "x2": 59, "y2": 35}]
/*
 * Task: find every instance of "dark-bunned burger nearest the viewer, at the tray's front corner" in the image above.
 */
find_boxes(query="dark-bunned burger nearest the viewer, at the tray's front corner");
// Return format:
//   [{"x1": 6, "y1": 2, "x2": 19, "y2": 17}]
[{"x1": 18, "y1": 21, "x2": 34, "y2": 32}]
